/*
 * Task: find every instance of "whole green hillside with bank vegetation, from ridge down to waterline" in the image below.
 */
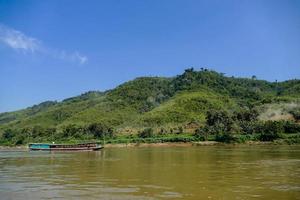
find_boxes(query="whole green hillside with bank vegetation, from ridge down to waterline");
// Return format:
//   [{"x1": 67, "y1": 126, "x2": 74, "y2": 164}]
[{"x1": 0, "y1": 68, "x2": 300, "y2": 145}]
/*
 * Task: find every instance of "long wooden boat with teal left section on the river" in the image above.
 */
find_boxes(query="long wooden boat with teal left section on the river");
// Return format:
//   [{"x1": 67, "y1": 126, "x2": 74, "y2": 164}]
[{"x1": 28, "y1": 142, "x2": 103, "y2": 151}]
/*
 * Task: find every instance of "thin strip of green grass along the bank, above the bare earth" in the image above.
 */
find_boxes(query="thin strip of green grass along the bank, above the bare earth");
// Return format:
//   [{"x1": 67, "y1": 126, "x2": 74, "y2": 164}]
[{"x1": 0, "y1": 133, "x2": 300, "y2": 146}]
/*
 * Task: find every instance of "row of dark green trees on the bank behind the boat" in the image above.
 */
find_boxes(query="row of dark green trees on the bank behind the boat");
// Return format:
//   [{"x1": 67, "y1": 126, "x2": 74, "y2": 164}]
[{"x1": 0, "y1": 123, "x2": 114, "y2": 145}]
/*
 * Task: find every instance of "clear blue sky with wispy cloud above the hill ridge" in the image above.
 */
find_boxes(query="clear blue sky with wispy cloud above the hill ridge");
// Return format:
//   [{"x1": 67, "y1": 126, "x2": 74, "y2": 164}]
[{"x1": 0, "y1": 0, "x2": 300, "y2": 112}]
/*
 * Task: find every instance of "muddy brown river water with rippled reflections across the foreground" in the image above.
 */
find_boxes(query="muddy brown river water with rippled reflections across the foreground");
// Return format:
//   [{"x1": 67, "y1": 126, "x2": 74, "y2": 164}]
[{"x1": 0, "y1": 146, "x2": 300, "y2": 200}]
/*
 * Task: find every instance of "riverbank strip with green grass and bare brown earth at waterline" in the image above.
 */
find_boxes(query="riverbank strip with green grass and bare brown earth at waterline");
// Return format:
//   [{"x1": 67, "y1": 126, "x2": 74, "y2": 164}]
[{"x1": 0, "y1": 133, "x2": 300, "y2": 149}]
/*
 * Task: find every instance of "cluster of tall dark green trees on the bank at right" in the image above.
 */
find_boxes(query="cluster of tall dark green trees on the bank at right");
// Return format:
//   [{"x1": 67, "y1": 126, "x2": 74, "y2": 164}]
[{"x1": 195, "y1": 109, "x2": 300, "y2": 142}]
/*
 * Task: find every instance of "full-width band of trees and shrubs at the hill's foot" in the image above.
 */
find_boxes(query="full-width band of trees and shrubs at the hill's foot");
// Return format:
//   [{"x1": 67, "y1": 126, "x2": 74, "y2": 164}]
[{"x1": 0, "y1": 109, "x2": 300, "y2": 145}]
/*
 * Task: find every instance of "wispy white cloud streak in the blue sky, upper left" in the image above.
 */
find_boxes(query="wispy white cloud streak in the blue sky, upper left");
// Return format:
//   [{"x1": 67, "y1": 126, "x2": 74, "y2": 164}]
[{"x1": 0, "y1": 24, "x2": 88, "y2": 64}]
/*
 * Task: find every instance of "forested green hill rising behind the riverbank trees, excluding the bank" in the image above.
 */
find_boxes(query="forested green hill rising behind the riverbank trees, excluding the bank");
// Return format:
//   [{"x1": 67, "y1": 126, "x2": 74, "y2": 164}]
[{"x1": 0, "y1": 68, "x2": 300, "y2": 143}]
